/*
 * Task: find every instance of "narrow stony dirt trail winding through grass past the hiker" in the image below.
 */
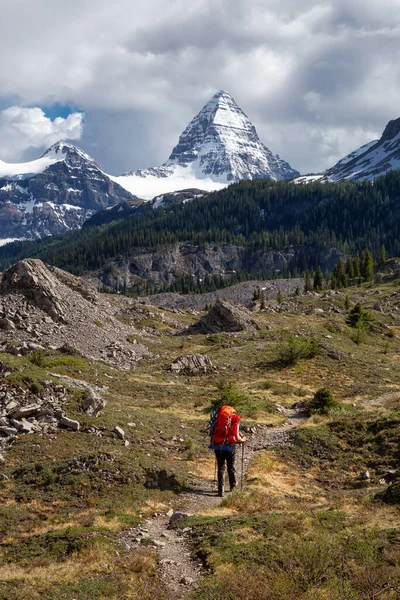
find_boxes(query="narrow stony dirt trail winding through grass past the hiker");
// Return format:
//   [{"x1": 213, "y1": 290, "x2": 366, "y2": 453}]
[{"x1": 121, "y1": 408, "x2": 304, "y2": 600}]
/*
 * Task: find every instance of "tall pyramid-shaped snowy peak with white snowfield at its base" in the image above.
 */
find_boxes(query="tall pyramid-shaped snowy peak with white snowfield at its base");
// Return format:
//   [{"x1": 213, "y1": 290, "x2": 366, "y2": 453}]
[{"x1": 113, "y1": 91, "x2": 299, "y2": 199}]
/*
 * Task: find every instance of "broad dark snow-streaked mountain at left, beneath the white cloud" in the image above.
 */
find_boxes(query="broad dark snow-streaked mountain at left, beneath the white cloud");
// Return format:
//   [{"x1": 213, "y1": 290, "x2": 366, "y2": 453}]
[{"x1": 0, "y1": 142, "x2": 134, "y2": 244}]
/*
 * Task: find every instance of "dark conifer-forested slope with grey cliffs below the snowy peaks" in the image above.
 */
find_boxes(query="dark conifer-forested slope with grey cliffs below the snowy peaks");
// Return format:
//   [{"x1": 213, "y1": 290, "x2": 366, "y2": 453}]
[{"x1": 0, "y1": 171, "x2": 400, "y2": 293}]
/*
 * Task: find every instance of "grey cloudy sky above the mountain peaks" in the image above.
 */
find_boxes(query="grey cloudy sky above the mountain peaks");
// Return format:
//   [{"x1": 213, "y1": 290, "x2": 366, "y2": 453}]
[{"x1": 0, "y1": 0, "x2": 400, "y2": 174}]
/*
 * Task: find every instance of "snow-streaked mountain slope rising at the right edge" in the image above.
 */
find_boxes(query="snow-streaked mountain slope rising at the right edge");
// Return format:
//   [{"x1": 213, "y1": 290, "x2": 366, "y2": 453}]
[{"x1": 295, "y1": 119, "x2": 400, "y2": 183}]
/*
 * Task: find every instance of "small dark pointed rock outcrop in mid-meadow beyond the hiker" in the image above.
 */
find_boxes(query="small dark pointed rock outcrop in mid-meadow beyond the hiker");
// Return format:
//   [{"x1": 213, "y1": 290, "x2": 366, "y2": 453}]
[{"x1": 185, "y1": 300, "x2": 260, "y2": 334}]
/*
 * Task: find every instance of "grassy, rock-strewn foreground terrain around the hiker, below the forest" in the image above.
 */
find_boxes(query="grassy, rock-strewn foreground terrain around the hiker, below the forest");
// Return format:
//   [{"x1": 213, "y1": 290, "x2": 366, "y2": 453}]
[{"x1": 0, "y1": 259, "x2": 400, "y2": 600}]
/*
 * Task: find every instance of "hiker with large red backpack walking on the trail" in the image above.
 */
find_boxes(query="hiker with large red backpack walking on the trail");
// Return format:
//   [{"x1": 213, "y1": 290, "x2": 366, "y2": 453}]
[{"x1": 210, "y1": 406, "x2": 247, "y2": 498}]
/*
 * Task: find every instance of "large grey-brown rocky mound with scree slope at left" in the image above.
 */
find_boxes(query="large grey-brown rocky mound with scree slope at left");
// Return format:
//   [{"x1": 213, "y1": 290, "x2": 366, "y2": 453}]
[{"x1": 0, "y1": 259, "x2": 150, "y2": 370}]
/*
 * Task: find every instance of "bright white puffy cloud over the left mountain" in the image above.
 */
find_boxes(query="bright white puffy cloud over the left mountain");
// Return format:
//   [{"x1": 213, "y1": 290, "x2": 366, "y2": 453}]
[{"x1": 0, "y1": 106, "x2": 84, "y2": 162}]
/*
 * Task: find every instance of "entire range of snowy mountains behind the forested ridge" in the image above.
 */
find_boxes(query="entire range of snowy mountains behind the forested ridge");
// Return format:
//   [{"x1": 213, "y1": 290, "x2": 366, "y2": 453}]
[{"x1": 0, "y1": 91, "x2": 400, "y2": 245}]
